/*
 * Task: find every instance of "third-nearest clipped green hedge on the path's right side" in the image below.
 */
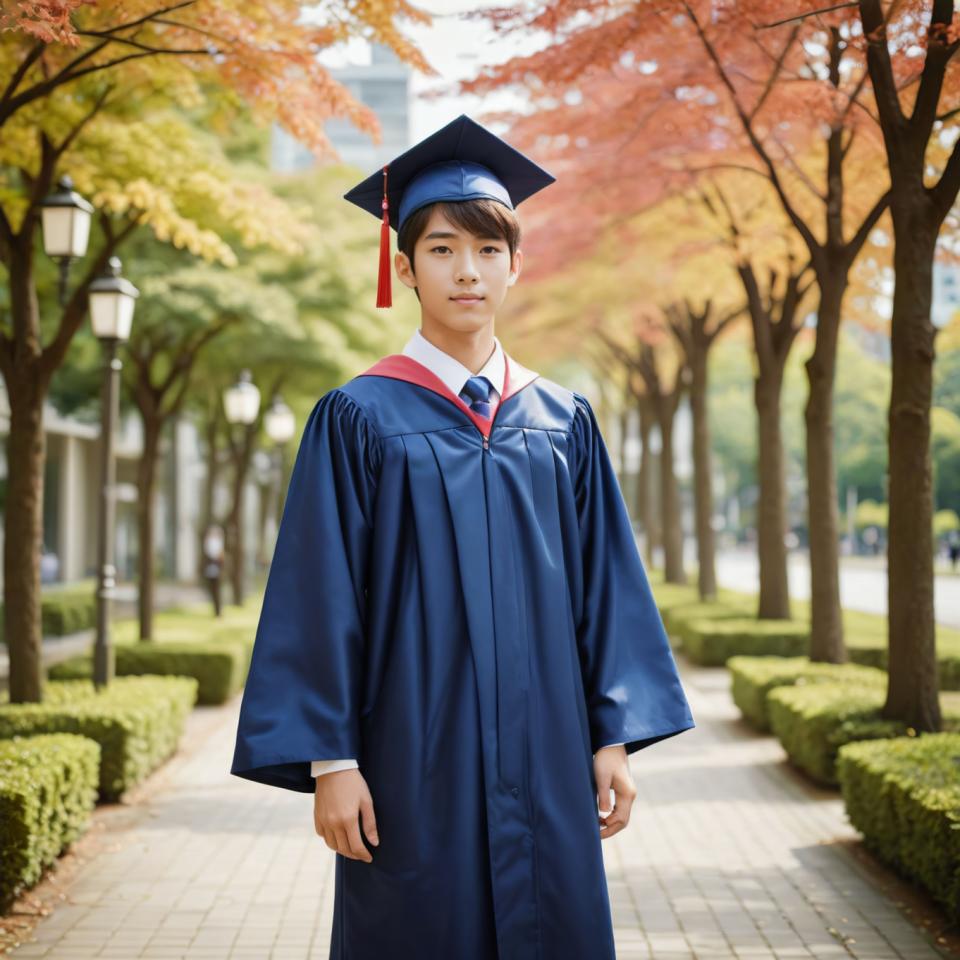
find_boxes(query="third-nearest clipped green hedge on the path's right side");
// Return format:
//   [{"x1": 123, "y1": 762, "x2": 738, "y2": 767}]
[{"x1": 727, "y1": 656, "x2": 887, "y2": 731}]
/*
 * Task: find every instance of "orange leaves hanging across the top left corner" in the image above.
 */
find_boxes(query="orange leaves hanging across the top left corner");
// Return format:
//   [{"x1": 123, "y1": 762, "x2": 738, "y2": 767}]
[{"x1": 0, "y1": 0, "x2": 433, "y2": 156}]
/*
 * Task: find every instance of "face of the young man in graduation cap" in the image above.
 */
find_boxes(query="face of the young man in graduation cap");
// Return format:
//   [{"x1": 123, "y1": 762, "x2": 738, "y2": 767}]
[{"x1": 394, "y1": 209, "x2": 523, "y2": 332}]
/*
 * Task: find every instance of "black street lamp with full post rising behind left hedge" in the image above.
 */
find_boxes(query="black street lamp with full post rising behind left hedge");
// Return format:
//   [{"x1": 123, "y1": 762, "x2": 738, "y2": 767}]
[{"x1": 89, "y1": 257, "x2": 139, "y2": 689}]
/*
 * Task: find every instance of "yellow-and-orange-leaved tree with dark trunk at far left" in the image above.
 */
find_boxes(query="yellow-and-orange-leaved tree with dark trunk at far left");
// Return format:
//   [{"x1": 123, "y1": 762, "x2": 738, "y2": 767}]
[{"x1": 0, "y1": 0, "x2": 426, "y2": 702}]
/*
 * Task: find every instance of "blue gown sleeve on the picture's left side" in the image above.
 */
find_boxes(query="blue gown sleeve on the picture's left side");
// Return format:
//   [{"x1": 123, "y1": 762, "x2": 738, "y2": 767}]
[{"x1": 230, "y1": 388, "x2": 381, "y2": 793}]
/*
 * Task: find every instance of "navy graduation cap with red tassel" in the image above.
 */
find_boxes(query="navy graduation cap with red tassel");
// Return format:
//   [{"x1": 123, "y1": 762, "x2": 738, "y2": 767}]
[{"x1": 343, "y1": 113, "x2": 556, "y2": 307}]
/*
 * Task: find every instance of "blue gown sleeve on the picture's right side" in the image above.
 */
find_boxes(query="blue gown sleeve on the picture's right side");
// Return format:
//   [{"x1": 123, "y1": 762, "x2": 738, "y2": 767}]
[{"x1": 572, "y1": 393, "x2": 695, "y2": 754}]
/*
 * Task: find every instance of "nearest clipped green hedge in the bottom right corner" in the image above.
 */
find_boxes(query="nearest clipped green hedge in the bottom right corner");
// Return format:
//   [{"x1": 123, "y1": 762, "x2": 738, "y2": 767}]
[{"x1": 837, "y1": 733, "x2": 960, "y2": 922}]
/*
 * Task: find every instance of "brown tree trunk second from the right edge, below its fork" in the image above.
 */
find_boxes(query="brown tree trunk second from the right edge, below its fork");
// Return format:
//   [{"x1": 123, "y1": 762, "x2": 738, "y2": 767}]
[{"x1": 804, "y1": 277, "x2": 847, "y2": 663}]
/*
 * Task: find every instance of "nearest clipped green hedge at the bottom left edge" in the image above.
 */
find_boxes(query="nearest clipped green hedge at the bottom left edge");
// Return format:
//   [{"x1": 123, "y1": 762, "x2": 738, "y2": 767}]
[{"x1": 0, "y1": 733, "x2": 100, "y2": 912}]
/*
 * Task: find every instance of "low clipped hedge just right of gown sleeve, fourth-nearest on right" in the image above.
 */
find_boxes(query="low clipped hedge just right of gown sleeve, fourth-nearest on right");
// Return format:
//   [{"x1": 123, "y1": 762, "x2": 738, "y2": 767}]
[{"x1": 678, "y1": 616, "x2": 810, "y2": 667}]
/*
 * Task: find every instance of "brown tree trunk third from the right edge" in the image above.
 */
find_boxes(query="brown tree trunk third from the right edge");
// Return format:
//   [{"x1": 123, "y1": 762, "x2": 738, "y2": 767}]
[{"x1": 753, "y1": 369, "x2": 790, "y2": 620}]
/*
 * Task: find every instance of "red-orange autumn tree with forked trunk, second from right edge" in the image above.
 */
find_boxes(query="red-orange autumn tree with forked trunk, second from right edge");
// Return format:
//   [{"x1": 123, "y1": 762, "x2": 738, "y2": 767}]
[{"x1": 461, "y1": 0, "x2": 889, "y2": 661}]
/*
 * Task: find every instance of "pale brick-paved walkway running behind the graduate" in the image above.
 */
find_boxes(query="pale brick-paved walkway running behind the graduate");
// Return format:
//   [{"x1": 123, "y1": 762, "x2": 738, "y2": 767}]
[{"x1": 5, "y1": 664, "x2": 956, "y2": 960}]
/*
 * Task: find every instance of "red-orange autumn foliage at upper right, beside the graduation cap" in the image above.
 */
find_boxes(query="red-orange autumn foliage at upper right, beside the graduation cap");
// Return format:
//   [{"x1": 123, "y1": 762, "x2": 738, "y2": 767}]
[{"x1": 459, "y1": 0, "x2": 960, "y2": 275}]
